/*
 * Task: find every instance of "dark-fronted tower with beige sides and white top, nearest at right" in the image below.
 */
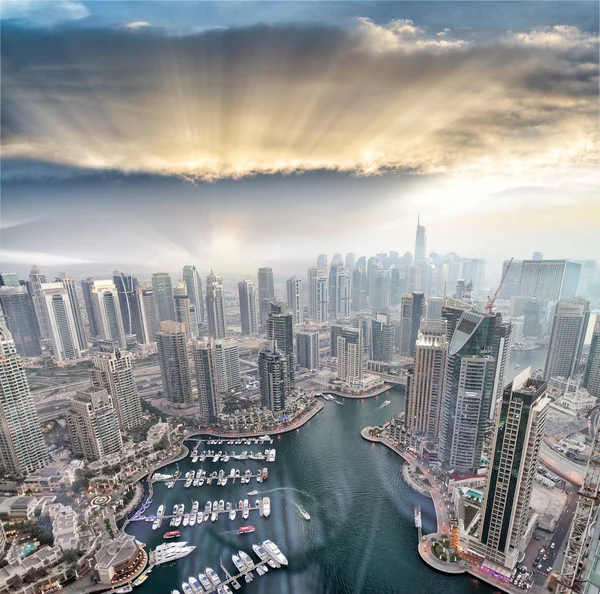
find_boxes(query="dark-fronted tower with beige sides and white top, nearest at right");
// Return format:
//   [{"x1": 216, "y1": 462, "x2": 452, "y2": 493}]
[{"x1": 480, "y1": 370, "x2": 550, "y2": 573}]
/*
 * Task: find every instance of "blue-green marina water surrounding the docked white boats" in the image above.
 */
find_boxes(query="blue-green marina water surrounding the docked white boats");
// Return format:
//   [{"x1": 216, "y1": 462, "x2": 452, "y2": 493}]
[{"x1": 127, "y1": 387, "x2": 494, "y2": 594}]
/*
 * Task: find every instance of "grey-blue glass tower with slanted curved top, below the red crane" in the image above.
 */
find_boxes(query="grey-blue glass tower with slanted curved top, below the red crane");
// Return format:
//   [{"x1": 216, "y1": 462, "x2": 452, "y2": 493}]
[{"x1": 439, "y1": 308, "x2": 498, "y2": 472}]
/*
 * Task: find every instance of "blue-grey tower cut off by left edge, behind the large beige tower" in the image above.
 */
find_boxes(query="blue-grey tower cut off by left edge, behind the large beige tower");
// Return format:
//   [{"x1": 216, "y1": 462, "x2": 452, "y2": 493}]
[{"x1": 0, "y1": 286, "x2": 41, "y2": 357}]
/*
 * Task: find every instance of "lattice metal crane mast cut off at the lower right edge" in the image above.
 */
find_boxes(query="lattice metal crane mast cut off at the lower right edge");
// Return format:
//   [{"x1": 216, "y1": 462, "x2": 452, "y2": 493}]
[{"x1": 556, "y1": 424, "x2": 600, "y2": 594}]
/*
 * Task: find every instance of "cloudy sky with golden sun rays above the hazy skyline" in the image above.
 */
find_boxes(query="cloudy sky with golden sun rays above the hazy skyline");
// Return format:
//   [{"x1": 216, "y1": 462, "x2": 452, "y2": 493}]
[{"x1": 0, "y1": 0, "x2": 600, "y2": 275}]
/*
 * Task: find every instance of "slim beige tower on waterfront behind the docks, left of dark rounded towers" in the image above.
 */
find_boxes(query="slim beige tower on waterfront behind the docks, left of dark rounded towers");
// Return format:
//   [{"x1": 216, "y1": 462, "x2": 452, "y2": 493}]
[{"x1": 194, "y1": 337, "x2": 219, "y2": 424}]
